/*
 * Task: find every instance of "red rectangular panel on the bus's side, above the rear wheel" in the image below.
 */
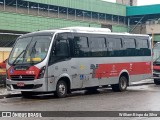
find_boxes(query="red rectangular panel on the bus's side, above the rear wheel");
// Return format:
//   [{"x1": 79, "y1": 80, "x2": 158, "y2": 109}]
[{"x1": 94, "y1": 62, "x2": 152, "y2": 78}]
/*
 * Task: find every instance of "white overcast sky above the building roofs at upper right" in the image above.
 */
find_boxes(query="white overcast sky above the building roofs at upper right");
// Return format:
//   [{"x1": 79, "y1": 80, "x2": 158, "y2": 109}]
[{"x1": 104, "y1": 0, "x2": 160, "y2": 5}]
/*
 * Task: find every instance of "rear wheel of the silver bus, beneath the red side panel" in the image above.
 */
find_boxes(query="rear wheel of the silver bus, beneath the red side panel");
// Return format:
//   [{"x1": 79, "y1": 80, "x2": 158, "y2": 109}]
[{"x1": 111, "y1": 76, "x2": 128, "y2": 92}]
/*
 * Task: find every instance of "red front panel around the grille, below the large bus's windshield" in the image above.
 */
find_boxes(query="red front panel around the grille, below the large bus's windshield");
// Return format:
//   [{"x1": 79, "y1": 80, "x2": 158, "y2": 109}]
[{"x1": 7, "y1": 66, "x2": 40, "y2": 79}]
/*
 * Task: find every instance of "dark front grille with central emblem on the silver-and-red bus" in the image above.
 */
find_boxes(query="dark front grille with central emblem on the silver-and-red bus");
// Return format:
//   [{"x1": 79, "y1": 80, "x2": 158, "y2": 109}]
[{"x1": 11, "y1": 75, "x2": 35, "y2": 81}]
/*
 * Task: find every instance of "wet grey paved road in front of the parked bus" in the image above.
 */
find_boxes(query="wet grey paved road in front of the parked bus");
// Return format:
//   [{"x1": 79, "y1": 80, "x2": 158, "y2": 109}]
[{"x1": 0, "y1": 84, "x2": 160, "y2": 120}]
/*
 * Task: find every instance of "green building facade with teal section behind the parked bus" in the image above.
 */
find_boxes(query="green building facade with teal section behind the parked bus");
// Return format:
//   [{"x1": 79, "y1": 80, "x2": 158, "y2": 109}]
[{"x1": 0, "y1": 0, "x2": 160, "y2": 62}]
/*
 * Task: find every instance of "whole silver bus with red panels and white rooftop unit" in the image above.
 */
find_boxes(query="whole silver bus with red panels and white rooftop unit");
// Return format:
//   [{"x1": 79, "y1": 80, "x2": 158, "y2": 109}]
[{"x1": 6, "y1": 27, "x2": 152, "y2": 97}]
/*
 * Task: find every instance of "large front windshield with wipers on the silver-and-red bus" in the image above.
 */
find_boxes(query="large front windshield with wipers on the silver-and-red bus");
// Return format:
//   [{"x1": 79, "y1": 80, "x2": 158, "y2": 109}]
[{"x1": 9, "y1": 36, "x2": 52, "y2": 65}]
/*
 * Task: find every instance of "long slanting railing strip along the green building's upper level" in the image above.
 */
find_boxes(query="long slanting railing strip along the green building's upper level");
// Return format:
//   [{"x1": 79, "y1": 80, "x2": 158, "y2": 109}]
[{"x1": 0, "y1": 5, "x2": 124, "y2": 25}]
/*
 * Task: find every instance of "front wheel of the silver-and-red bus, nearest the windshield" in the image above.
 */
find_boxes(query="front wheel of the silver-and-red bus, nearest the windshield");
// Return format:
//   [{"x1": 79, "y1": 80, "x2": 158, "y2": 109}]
[{"x1": 55, "y1": 80, "x2": 67, "y2": 98}]
